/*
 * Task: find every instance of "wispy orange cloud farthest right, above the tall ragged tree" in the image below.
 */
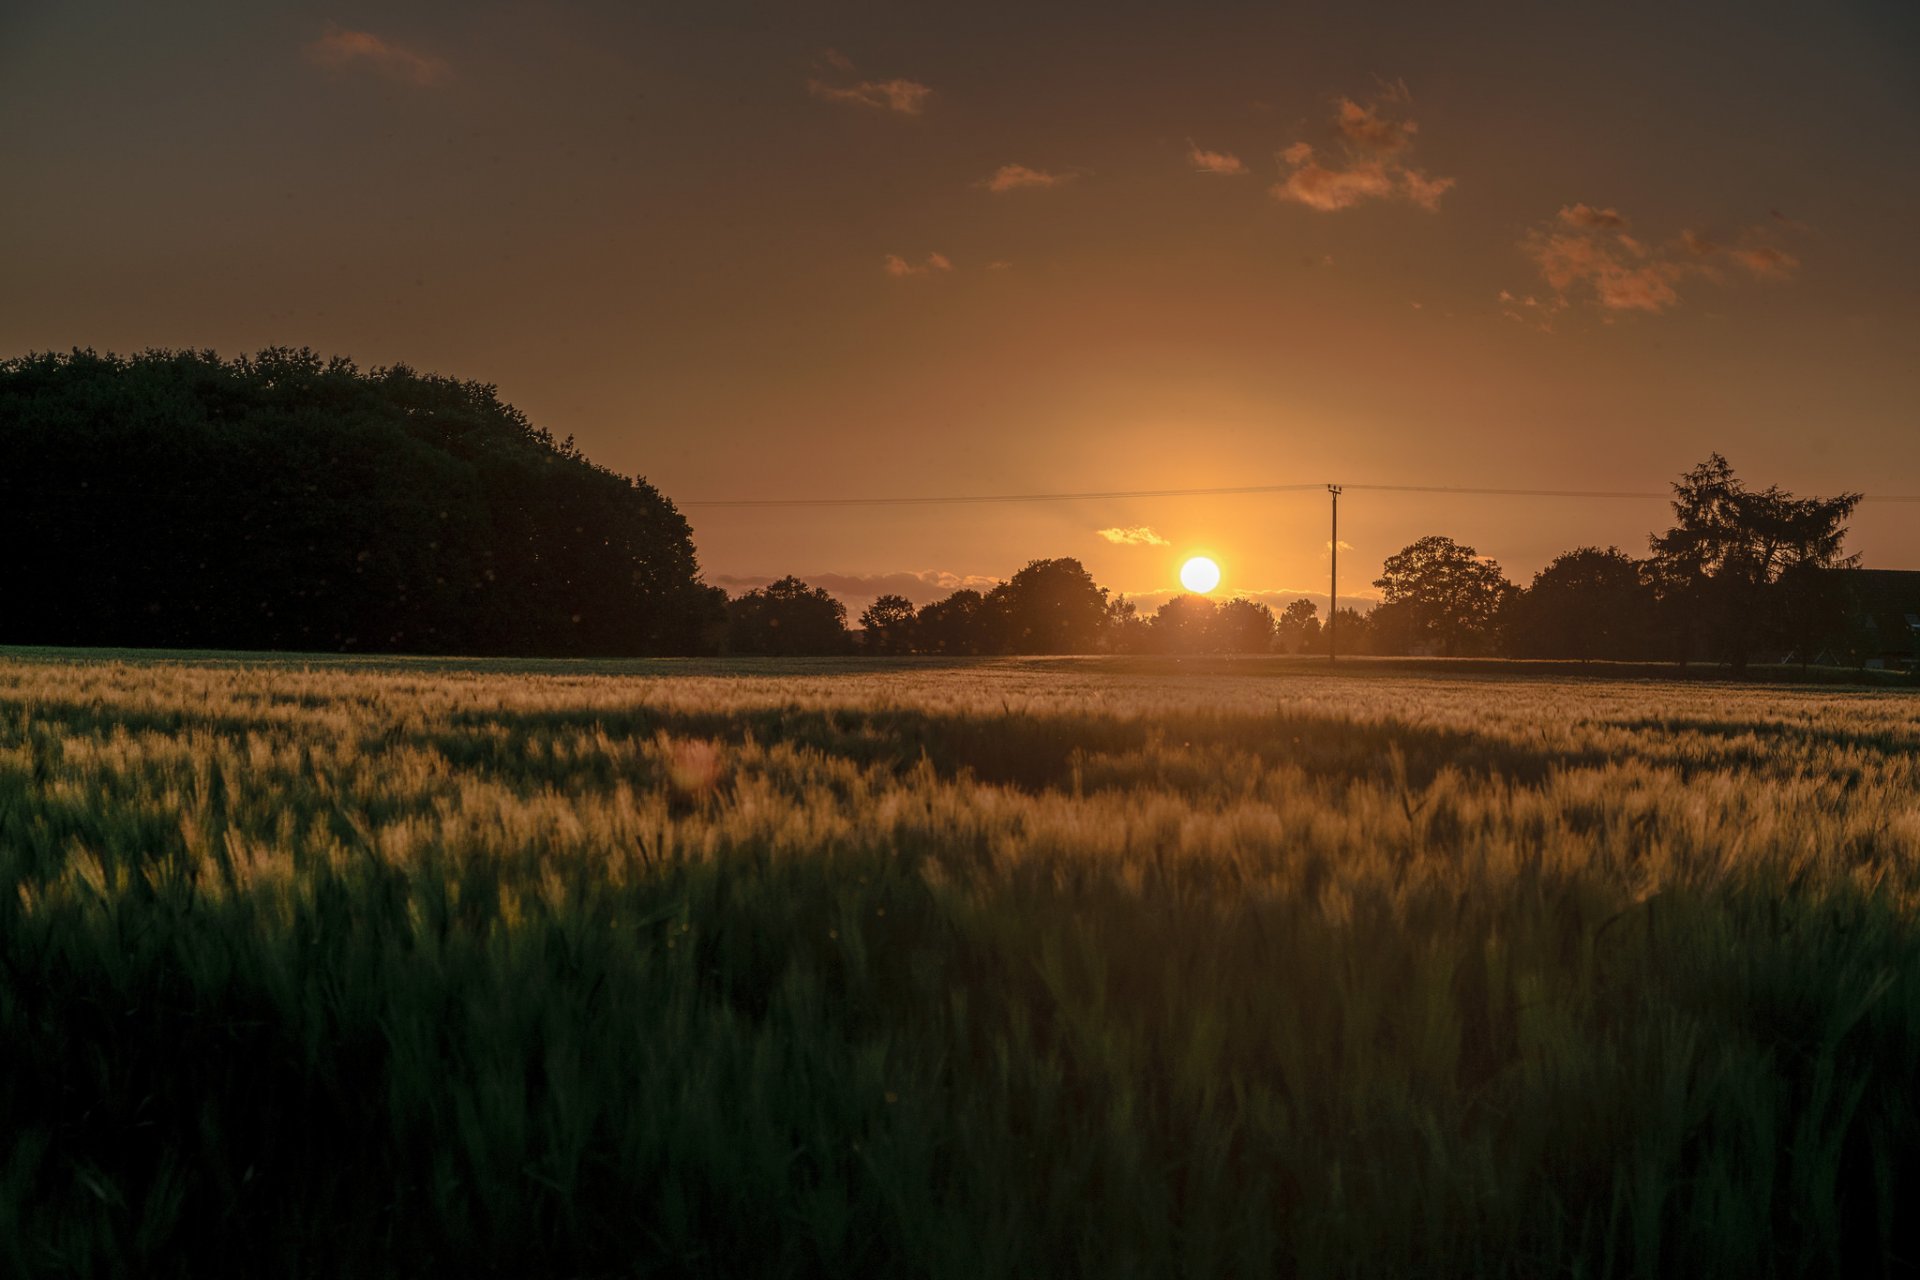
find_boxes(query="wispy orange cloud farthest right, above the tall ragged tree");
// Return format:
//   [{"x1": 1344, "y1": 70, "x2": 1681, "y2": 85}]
[{"x1": 1500, "y1": 203, "x2": 1799, "y2": 330}]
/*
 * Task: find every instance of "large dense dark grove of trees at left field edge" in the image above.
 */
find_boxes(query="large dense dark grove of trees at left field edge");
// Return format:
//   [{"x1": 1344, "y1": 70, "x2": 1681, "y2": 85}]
[{"x1": 0, "y1": 349, "x2": 724, "y2": 654}]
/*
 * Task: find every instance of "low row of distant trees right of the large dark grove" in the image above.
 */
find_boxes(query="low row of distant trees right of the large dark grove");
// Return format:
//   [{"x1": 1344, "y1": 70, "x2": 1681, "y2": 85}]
[{"x1": 728, "y1": 453, "x2": 1860, "y2": 670}]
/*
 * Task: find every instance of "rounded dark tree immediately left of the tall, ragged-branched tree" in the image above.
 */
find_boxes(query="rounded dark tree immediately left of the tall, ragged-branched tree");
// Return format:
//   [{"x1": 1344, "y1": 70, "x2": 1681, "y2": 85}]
[{"x1": 1501, "y1": 547, "x2": 1653, "y2": 662}]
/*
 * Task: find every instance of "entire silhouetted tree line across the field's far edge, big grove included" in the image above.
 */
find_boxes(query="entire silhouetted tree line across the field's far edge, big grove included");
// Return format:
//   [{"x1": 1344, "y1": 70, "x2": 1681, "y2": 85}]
[{"x1": 0, "y1": 347, "x2": 1860, "y2": 668}]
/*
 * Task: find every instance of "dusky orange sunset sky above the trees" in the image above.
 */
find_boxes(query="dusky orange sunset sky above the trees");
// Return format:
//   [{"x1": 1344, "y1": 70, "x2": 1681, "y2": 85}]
[{"x1": 0, "y1": 0, "x2": 1920, "y2": 612}]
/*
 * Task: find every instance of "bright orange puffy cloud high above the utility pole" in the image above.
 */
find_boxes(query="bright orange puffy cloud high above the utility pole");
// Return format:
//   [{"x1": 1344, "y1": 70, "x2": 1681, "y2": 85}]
[{"x1": 1267, "y1": 81, "x2": 1453, "y2": 213}]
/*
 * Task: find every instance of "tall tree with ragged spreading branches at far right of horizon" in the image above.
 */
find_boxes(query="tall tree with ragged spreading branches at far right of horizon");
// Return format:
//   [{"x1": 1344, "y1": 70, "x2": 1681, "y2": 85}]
[{"x1": 1649, "y1": 453, "x2": 1860, "y2": 672}]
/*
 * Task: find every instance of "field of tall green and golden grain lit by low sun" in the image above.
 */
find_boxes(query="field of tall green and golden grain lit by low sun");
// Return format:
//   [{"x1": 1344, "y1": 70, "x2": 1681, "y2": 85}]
[{"x1": 0, "y1": 651, "x2": 1920, "y2": 1276}]
